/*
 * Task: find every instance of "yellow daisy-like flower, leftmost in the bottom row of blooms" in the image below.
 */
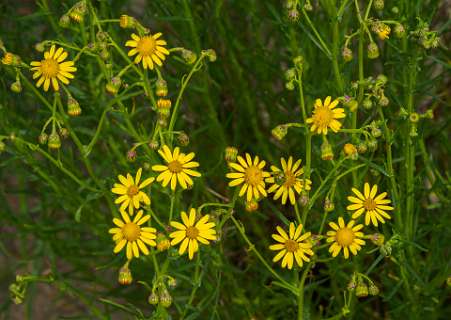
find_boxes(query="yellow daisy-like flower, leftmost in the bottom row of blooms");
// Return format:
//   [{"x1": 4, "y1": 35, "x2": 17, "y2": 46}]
[{"x1": 108, "y1": 210, "x2": 157, "y2": 260}]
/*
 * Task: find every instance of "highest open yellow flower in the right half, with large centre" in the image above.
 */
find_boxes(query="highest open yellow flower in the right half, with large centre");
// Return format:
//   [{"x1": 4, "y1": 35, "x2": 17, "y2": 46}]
[{"x1": 306, "y1": 96, "x2": 346, "y2": 134}]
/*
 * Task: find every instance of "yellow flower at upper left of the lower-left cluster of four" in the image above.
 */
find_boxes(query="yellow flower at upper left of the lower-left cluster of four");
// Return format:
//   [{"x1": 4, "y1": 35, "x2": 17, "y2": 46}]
[{"x1": 111, "y1": 168, "x2": 155, "y2": 215}]
